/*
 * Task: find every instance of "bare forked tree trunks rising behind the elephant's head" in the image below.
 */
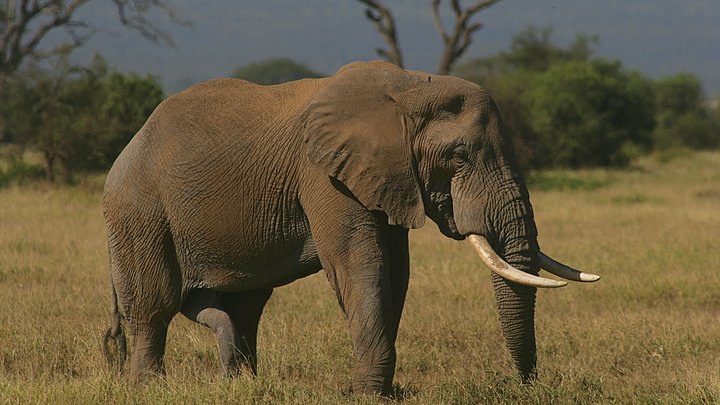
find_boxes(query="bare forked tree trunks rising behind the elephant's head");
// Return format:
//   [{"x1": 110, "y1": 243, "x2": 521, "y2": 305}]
[{"x1": 359, "y1": 0, "x2": 500, "y2": 75}]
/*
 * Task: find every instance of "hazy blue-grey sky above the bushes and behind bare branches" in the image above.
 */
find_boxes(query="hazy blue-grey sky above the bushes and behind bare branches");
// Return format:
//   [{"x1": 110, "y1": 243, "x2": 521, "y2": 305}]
[{"x1": 62, "y1": 0, "x2": 720, "y2": 97}]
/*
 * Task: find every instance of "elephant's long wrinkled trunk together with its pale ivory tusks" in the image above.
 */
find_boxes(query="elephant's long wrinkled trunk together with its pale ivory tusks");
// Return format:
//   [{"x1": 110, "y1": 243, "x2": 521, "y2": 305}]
[{"x1": 453, "y1": 166, "x2": 556, "y2": 383}]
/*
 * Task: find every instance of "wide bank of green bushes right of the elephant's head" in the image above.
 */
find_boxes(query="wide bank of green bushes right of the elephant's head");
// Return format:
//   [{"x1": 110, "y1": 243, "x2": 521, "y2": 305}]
[{"x1": 456, "y1": 27, "x2": 720, "y2": 168}]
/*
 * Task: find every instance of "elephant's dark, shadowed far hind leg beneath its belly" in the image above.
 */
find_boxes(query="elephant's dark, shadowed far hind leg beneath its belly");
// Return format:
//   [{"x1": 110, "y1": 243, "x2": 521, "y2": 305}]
[{"x1": 220, "y1": 288, "x2": 272, "y2": 375}]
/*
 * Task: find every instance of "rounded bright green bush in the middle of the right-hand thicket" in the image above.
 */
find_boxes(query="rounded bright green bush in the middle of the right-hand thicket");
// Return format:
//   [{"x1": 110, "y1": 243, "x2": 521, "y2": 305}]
[{"x1": 528, "y1": 59, "x2": 654, "y2": 168}]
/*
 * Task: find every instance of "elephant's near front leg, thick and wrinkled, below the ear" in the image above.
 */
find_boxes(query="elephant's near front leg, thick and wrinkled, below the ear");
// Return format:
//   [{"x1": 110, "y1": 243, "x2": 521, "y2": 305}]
[{"x1": 307, "y1": 199, "x2": 399, "y2": 394}]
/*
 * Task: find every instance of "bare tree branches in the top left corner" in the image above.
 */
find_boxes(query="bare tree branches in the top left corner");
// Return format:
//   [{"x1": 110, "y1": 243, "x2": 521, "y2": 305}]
[{"x1": 0, "y1": 0, "x2": 181, "y2": 79}]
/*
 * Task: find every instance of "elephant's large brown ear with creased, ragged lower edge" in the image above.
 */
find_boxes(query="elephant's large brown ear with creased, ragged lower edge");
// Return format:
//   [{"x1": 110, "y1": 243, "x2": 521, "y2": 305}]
[{"x1": 304, "y1": 63, "x2": 425, "y2": 228}]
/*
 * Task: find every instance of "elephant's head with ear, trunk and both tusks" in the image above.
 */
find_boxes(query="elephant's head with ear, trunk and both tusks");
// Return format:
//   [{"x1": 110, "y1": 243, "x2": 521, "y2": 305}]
[{"x1": 304, "y1": 62, "x2": 599, "y2": 381}]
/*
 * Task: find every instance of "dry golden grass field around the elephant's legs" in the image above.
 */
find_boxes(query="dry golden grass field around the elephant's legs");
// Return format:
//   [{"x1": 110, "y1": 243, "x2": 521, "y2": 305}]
[{"x1": 0, "y1": 152, "x2": 720, "y2": 404}]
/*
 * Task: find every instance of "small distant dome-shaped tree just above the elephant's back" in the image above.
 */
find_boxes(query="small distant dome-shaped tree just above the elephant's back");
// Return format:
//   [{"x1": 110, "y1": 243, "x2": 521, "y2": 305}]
[{"x1": 232, "y1": 58, "x2": 323, "y2": 85}]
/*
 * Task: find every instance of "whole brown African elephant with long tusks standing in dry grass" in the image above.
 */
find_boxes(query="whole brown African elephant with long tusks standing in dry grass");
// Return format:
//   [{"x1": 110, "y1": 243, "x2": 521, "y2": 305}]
[{"x1": 103, "y1": 62, "x2": 597, "y2": 394}]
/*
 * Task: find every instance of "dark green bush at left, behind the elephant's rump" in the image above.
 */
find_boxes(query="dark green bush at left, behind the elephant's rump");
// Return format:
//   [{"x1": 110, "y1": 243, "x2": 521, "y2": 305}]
[{"x1": 0, "y1": 57, "x2": 163, "y2": 181}]
